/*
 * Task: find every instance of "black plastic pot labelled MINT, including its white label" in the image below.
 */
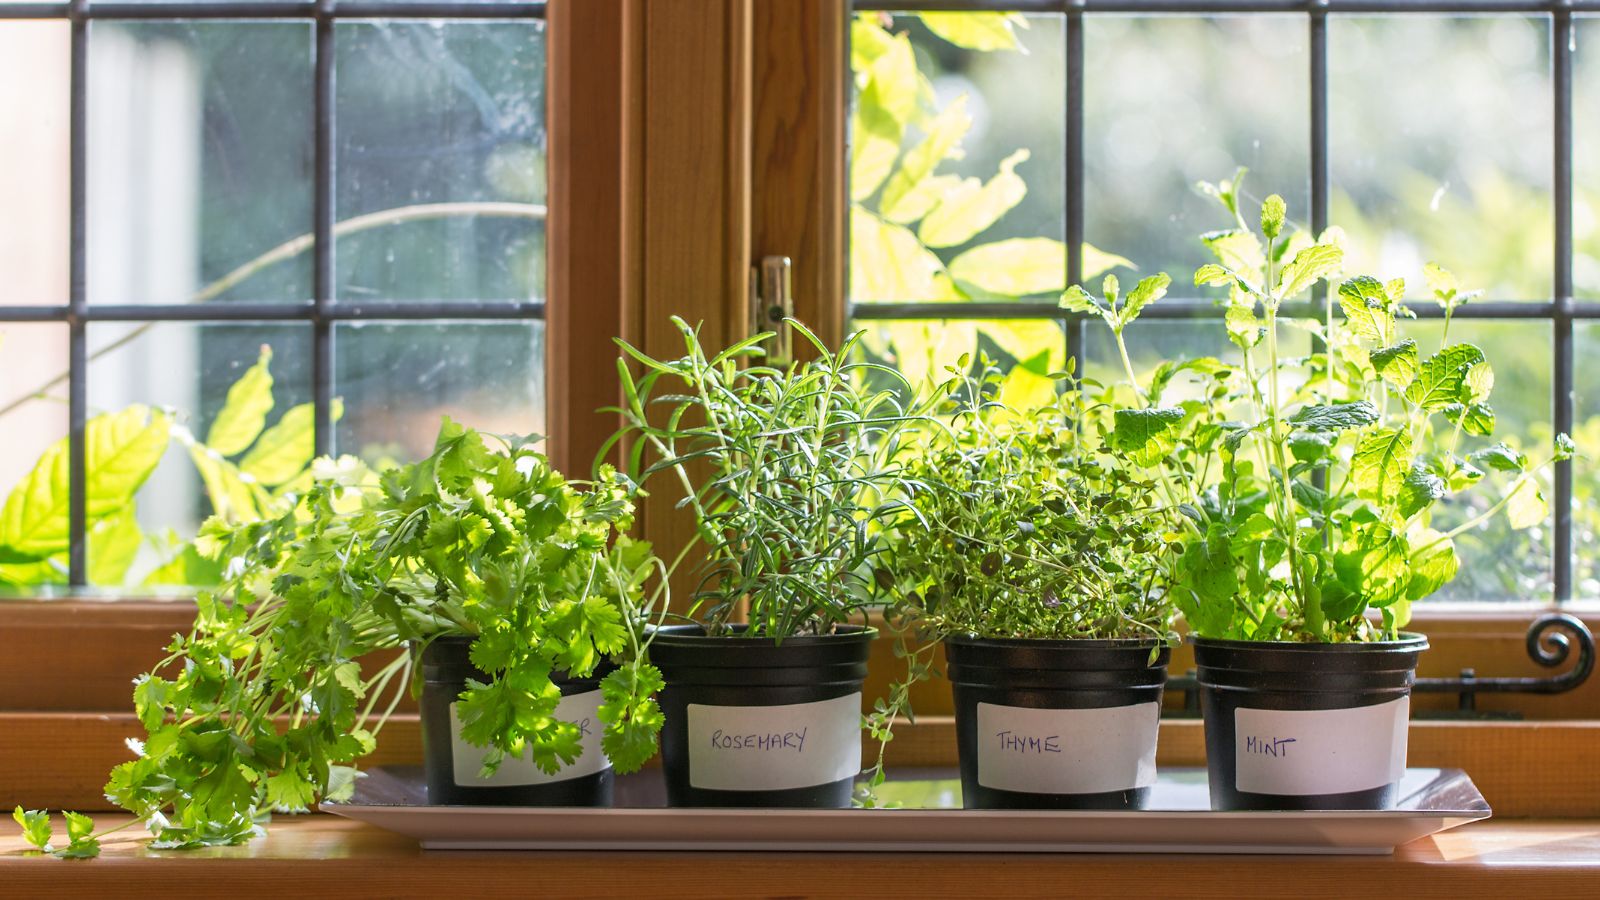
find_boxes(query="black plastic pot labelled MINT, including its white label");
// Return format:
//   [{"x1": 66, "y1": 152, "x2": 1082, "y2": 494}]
[{"x1": 1195, "y1": 634, "x2": 1427, "y2": 810}]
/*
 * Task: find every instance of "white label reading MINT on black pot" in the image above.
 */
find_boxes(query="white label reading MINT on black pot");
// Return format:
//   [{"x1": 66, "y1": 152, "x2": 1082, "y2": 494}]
[{"x1": 1234, "y1": 697, "x2": 1411, "y2": 796}]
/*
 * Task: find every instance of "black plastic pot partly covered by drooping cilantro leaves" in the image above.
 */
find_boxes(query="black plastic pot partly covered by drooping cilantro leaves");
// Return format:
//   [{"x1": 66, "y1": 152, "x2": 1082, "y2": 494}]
[{"x1": 421, "y1": 637, "x2": 613, "y2": 806}]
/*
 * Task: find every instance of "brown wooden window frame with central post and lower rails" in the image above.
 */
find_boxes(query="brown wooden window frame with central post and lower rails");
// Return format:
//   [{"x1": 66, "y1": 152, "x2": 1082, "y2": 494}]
[{"x1": 0, "y1": 0, "x2": 1600, "y2": 815}]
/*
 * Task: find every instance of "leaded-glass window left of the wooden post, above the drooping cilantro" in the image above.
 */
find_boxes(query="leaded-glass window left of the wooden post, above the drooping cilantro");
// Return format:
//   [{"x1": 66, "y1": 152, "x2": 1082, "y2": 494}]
[{"x1": 0, "y1": 0, "x2": 546, "y2": 593}]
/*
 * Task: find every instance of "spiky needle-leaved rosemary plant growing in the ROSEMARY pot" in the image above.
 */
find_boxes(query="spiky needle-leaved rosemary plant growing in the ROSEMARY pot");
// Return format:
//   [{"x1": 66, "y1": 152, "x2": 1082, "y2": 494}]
[{"x1": 608, "y1": 317, "x2": 917, "y2": 641}]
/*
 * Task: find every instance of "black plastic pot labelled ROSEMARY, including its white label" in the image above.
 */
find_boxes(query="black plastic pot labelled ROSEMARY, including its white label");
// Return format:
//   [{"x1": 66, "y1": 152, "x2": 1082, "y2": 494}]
[{"x1": 650, "y1": 625, "x2": 877, "y2": 809}]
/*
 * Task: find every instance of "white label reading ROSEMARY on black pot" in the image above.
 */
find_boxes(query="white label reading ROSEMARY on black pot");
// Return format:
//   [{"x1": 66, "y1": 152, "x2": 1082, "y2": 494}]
[{"x1": 688, "y1": 692, "x2": 861, "y2": 791}]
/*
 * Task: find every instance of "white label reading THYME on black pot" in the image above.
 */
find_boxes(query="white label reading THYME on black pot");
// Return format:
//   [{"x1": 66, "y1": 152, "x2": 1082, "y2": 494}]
[{"x1": 978, "y1": 701, "x2": 1162, "y2": 794}]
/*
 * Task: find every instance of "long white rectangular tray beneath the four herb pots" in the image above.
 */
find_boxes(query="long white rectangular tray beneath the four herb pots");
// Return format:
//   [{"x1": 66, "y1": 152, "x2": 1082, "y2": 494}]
[{"x1": 322, "y1": 769, "x2": 1490, "y2": 854}]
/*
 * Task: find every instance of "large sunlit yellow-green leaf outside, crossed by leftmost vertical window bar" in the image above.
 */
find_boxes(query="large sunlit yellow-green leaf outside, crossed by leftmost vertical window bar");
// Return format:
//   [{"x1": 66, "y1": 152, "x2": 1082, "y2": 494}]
[{"x1": 0, "y1": 405, "x2": 170, "y2": 559}]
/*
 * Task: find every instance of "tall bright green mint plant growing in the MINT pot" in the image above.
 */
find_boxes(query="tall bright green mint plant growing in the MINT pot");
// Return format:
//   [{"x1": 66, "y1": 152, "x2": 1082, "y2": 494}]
[{"x1": 1062, "y1": 173, "x2": 1573, "y2": 642}]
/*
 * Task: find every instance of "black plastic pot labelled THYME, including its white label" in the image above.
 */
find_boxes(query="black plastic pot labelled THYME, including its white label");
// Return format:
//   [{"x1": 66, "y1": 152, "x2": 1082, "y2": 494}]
[{"x1": 944, "y1": 636, "x2": 1171, "y2": 809}]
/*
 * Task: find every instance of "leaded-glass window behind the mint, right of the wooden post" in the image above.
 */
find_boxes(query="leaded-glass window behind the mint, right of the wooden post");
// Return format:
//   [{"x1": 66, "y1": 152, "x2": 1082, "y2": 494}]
[{"x1": 848, "y1": 0, "x2": 1600, "y2": 602}]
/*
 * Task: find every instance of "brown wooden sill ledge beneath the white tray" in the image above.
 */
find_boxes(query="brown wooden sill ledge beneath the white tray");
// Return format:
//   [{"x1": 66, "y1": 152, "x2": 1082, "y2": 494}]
[{"x1": 0, "y1": 815, "x2": 1600, "y2": 898}]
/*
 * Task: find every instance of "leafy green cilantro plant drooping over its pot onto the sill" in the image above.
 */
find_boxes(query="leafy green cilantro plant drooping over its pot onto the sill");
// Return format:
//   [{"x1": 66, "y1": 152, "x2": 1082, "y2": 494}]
[{"x1": 24, "y1": 420, "x2": 664, "y2": 847}]
